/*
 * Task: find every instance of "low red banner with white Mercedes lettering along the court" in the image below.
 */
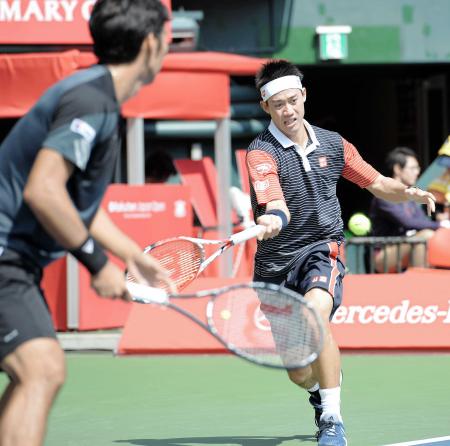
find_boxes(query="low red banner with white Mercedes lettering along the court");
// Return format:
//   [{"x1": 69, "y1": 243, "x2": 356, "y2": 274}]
[{"x1": 119, "y1": 269, "x2": 450, "y2": 354}]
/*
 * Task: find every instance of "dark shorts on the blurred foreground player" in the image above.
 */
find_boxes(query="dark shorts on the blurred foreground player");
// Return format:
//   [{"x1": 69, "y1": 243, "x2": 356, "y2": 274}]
[{"x1": 0, "y1": 250, "x2": 56, "y2": 361}]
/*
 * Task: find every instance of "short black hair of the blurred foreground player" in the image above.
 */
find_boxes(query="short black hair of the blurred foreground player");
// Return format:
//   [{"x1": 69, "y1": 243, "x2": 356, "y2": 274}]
[{"x1": 89, "y1": 0, "x2": 169, "y2": 64}]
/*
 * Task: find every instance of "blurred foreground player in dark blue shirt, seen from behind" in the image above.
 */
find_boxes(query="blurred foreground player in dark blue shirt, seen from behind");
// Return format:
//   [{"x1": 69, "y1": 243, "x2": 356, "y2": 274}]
[{"x1": 0, "y1": 0, "x2": 174, "y2": 446}]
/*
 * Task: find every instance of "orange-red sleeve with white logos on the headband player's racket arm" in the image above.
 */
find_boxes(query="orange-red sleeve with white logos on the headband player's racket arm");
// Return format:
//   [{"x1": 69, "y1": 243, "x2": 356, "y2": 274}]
[{"x1": 247, "y1": 150, "x2": 284, "y2": 205}]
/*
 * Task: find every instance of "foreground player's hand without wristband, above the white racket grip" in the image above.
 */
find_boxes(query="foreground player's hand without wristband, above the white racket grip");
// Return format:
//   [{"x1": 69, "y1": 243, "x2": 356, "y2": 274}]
[{"x1": 127, "y1": 252, "x2": 177, "y2": 294}]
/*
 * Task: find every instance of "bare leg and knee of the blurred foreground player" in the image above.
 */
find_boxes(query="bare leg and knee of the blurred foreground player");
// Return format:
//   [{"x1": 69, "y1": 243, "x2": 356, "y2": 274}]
[{"x1": 0, "y1": 338, "x2": 65, "y2": 446}]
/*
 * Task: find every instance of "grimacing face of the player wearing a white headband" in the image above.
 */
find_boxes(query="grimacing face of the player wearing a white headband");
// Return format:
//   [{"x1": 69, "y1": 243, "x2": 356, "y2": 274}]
[{"x1": 261, "y1": 88, "x2": 306, "y2": 137}]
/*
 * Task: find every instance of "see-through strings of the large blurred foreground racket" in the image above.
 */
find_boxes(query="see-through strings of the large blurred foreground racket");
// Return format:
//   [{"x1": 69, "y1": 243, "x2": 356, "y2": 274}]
[{"x1": 212, "y1": 288, "x2": 322, "y2": 368}]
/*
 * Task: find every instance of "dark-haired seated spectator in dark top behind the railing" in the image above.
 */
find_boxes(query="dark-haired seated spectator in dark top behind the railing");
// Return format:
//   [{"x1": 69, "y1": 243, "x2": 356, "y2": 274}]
[{"x1": 370, "y1": 147, "x2": 450, "y2": 272}]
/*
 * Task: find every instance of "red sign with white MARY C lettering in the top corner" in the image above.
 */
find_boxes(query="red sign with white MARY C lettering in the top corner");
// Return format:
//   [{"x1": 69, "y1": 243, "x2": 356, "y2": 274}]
[{"x1": 0, "y1": 0, "x2": 170, "y2": 45}]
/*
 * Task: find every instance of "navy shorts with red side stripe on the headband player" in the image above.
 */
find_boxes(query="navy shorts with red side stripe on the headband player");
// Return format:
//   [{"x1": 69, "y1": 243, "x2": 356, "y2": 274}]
[{"x1": 253, "y1": 241, "x2": 345, "y2": 319}]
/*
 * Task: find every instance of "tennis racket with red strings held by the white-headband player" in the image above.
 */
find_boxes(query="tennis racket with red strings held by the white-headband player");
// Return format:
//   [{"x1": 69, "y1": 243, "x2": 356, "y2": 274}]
[{"x1": 127, "y1": 225, "x2": 263, "y2": 292}]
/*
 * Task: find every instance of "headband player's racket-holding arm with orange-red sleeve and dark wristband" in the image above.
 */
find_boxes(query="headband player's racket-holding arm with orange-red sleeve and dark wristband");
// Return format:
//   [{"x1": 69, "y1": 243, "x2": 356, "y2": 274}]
[{"x1": 247, "y1": 150, "x2": 291, "y2": 240}]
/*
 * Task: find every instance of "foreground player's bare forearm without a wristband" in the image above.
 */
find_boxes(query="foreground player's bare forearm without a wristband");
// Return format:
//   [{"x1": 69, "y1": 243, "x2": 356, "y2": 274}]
[{"x1": 89, "y1": 208, "x2": 141, "y2": 262}]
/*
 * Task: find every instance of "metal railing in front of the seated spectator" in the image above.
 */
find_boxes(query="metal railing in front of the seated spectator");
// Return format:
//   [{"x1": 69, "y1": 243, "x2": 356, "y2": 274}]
[{"x1": 345, "y1": 236, "x2": 428, "y2": 274}]
